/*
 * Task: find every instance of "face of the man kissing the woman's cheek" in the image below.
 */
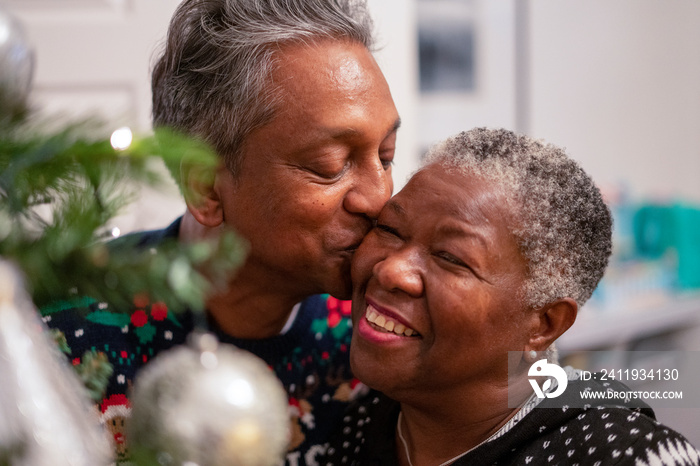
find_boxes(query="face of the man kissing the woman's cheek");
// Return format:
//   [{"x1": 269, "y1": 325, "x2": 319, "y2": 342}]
[{"x1": 217, "y1": 41, "x2": 399, "y2": 298}]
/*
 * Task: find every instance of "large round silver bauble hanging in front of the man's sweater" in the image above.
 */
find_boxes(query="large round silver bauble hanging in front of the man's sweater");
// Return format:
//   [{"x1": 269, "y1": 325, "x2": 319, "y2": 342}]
[{"x1": 127, "y1": 332, "x2": 289, "y2": 466}]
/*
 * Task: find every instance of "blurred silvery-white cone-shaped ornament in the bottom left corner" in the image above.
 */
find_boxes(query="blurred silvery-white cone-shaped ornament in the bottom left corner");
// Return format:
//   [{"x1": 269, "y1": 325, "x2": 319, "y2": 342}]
[{"x1": 0, "y1": 260, "x2": 112, "y2": 466}]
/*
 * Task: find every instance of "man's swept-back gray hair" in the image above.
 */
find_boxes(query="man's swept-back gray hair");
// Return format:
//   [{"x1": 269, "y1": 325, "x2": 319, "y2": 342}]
[{"x1": 151, "y1": 0, "x2": 373, "y2": 177}]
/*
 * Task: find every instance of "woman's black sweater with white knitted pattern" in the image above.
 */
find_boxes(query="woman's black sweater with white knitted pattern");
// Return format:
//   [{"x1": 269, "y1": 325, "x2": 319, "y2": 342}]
[{"x1": 322, "y1": 368, "x2": 700, "y2": 466}]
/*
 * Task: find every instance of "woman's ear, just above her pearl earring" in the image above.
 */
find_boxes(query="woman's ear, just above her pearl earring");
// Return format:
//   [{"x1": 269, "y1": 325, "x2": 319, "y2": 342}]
[{"x1": 525, "y1": 298, "x2": 578, "y2": 352}]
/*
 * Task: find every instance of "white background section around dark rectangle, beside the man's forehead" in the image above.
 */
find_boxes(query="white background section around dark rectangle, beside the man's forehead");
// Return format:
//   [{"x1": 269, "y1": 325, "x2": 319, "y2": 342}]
[{"x1": 369, "y1": 0, "x2": 516, "y2": 192}]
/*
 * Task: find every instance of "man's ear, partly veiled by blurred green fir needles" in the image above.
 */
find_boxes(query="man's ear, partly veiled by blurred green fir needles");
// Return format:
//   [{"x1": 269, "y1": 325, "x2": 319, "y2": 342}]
[{"x1": 180, "y1": 162, "x2": 224, "y2": 228}]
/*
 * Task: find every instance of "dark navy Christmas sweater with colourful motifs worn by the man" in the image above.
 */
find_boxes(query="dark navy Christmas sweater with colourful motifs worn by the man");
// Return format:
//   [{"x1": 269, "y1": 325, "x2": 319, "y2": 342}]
[{"x1": 41, "y1": 221, "x2": 366, "y2": 466}]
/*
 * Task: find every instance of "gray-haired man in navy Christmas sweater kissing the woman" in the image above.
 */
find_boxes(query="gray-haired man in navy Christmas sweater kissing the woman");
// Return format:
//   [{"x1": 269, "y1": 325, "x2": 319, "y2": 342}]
[{"x1": 45, "y1": 0, "x2": 399, "y2": 464}]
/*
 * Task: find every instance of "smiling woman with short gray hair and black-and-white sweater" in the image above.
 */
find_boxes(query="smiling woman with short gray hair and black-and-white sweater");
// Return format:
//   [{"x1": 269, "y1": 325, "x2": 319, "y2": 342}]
[{"x1": 328, "y1": 129, "x2": 698, "y2": 466}]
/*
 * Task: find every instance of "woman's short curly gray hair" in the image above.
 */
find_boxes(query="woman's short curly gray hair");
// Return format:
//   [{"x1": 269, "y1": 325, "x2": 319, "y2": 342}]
[{"x1": 425, "y1": 128, "x2": 612, "y2": 308}]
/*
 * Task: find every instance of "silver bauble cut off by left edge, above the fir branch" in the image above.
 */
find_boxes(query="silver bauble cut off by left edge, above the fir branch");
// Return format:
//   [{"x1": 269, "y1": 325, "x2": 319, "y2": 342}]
[{"x1": 0, "y1": 5, "x2": 34, "y2": 109}]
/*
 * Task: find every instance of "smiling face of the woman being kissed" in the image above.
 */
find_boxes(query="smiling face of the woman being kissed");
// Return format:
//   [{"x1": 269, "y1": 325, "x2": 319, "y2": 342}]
[{"x1": 351, "y1": 165, "x2": 535, "y2": 401}]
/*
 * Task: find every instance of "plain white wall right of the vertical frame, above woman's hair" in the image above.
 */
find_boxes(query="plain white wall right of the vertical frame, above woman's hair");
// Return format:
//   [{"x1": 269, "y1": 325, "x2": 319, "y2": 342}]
[{"x1": 528, "y1": 0, "x2": 700, "y2": 202}]
